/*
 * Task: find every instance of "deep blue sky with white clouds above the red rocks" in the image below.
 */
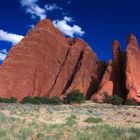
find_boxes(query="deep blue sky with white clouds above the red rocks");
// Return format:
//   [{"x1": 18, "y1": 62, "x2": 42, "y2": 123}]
[{"x1": 0, "y1": 0, "x2": 140, "y2": 61}]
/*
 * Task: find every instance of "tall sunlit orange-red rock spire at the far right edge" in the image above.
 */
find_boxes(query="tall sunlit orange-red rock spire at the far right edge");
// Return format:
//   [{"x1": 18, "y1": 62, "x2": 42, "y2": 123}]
[{"x1": 126, "y1": 34, "x2": 140, "y2": 102}]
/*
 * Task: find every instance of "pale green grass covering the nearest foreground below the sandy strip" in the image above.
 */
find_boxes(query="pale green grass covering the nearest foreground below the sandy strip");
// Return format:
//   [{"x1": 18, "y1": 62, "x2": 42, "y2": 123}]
[{"x1": 0, "y1": 110, "x2": 140, "y2": 140}]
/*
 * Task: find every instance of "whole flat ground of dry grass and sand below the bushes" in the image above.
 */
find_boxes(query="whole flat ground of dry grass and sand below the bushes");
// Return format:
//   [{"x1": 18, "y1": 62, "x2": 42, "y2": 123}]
[{"x1": 0, "y1": 102, "x2": 140, "y2": 140}]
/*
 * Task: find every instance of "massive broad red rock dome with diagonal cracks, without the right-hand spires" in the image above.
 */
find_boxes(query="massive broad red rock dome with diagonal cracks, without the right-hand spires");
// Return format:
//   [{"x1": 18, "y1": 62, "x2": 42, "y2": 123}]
[{"x1": 0, "y1": 19, "x2": 102, "y2": 100}]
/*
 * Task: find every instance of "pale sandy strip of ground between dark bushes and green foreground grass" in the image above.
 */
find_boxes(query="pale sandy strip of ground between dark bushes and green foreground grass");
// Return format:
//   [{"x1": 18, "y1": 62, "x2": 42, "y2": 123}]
[{"x1": 0, "y1": 102, "x2": 140, "y2": 128}]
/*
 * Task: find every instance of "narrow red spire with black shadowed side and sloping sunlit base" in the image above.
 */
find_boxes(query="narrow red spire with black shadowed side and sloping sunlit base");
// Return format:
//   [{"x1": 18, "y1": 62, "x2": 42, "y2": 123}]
[{"x1": 91, "y1": 40, "x2": 123, "y2": 102}]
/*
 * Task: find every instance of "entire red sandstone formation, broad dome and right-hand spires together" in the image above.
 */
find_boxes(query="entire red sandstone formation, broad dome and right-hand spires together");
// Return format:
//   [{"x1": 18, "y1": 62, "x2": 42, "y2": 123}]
[{"x1": 0, "y1": 19, "x2": 140, "y2": 102}]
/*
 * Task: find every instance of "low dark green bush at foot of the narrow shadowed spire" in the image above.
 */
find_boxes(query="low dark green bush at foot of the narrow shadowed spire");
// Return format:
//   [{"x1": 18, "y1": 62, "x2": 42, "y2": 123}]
[{"x1": 104, "y1": 94, "x2": 123, "y2": 105}]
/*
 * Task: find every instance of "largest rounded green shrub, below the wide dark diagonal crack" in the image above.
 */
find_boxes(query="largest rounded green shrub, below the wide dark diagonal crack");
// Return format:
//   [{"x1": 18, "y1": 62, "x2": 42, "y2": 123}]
[{"x1": 64, "y1": 90, "x2": 86, "y2": 104}]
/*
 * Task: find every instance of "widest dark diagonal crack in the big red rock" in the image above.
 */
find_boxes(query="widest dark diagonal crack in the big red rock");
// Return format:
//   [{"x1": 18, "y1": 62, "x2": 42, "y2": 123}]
[{"x1": 62, "y1": 51, "x2": 84, "y2": 94}]
